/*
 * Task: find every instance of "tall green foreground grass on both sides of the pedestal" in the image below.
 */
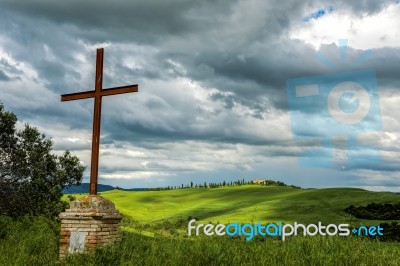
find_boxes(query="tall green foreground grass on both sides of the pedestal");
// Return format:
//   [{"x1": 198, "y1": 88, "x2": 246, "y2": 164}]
[{"x1": 0, "y1": 217, "x2": 400, "y2": 265}]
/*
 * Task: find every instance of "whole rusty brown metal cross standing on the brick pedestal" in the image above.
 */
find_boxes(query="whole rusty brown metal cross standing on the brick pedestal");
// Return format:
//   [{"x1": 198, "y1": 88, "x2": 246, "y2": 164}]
[{"x1": 61, "y1": 48, "x2": 139, "y2": 195}]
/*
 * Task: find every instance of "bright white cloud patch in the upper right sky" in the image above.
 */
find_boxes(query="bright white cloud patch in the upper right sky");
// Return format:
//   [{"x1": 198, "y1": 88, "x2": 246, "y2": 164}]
[{"x1": 289, "y1": 4, "x2": 400, "y2": 50}]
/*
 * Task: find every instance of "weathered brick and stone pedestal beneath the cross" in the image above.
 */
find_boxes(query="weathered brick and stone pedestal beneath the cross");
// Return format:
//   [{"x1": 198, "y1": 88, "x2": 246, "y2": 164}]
[{"x1": 59, "y1": 195, "x2": 122, "y2": 258}]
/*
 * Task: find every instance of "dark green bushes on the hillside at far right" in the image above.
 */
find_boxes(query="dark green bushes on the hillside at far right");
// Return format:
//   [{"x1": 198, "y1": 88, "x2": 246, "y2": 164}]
[{"x1": 344, "y1": 202, "x2": 400, "y2": 220}]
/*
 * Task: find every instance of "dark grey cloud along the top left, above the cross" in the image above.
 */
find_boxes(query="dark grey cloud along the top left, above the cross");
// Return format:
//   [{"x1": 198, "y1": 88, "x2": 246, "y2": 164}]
[{"x1": 2, "y1": 0, "x2": 236, "y2": 42}]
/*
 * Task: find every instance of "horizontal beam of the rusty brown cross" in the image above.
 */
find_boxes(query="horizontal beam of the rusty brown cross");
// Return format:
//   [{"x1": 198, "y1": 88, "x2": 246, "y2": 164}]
[{"x1": 61, "y1": 85, "x2": 139, "y2": 102}]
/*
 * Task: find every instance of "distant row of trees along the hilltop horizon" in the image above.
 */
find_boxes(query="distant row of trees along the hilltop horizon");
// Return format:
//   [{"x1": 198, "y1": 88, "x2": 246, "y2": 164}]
[{"x1": 144, "y1": 178, "x2": 301, "y2": 191}]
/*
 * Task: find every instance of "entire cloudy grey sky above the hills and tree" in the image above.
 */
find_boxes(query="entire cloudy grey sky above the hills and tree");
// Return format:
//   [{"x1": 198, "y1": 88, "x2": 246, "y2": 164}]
[{"x1": 0, "y1": 0, "x2": 400, "y2": 191}]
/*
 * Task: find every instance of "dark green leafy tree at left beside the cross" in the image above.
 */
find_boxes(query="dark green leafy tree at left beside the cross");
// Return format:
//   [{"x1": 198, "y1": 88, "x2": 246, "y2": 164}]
[{"x1": 0, "y1": 103, "x2": 85, "y2": 217}]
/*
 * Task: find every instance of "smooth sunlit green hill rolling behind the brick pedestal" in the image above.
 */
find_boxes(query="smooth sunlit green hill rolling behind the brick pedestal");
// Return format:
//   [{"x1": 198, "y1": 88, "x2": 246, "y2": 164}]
[{"x1": 69, "y1": 185, "x2": 400, "y2": 225}]
